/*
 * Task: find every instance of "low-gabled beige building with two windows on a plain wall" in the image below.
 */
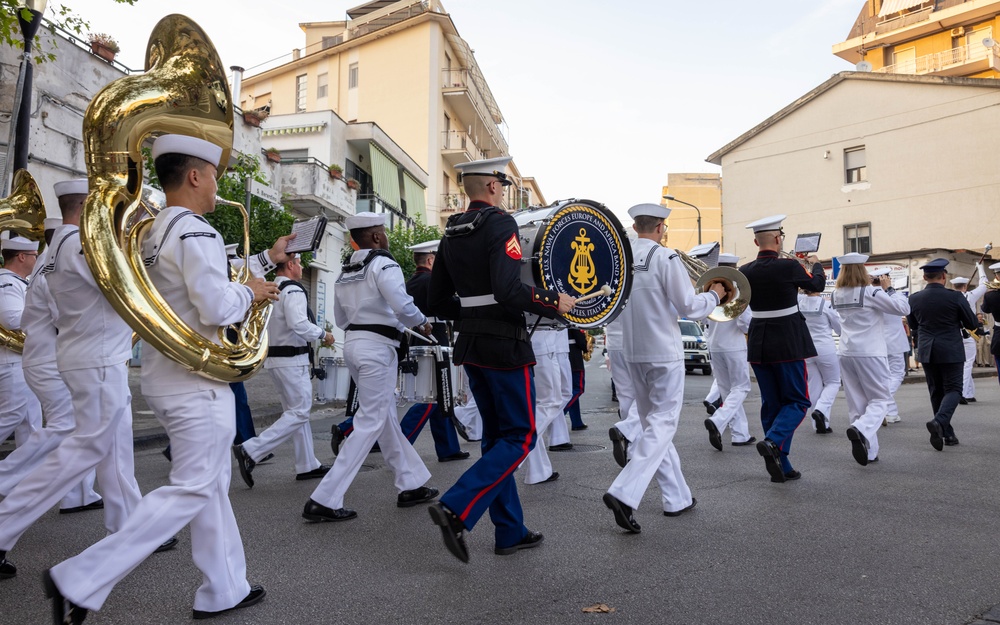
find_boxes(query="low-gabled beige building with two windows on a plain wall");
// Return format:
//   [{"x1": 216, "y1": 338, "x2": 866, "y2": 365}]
[{"x1": 707, "y1": 72, "x2": 1000, "y2": 286}]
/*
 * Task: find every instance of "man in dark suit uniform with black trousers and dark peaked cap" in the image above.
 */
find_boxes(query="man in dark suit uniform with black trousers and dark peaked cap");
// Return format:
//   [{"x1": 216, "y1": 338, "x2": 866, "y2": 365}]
[{"x1": 906, "y1": 258, "x2": 979, "y2": 451}]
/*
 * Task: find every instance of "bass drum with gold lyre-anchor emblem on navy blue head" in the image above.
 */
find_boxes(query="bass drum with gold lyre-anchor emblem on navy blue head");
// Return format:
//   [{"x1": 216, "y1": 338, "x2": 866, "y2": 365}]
[{"x1": 514, "y1": 200, "x2": 632, "y2": 328}]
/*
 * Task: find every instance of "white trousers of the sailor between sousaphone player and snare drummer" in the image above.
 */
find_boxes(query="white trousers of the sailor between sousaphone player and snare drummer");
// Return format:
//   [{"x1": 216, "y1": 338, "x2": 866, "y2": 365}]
[{"x1": 243, "y1": 365, "x2": 320, "y2": 473}]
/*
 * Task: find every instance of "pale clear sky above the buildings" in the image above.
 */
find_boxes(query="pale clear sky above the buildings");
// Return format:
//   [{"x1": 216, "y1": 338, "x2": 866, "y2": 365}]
[{"x1": 71, "y1": 0, "x2": 864, "y2": 214}]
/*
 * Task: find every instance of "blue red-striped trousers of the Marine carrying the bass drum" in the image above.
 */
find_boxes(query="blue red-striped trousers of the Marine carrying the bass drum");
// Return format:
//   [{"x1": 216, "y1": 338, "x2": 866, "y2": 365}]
[{"x1": 441, "y1": 365, "x2": 537, "y2": 548}]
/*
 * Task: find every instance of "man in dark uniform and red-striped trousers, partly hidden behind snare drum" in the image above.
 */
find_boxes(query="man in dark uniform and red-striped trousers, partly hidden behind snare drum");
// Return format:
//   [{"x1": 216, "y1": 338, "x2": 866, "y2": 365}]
[{"x1": 399, "y1": 241, "x2": 469, "y2": 462}]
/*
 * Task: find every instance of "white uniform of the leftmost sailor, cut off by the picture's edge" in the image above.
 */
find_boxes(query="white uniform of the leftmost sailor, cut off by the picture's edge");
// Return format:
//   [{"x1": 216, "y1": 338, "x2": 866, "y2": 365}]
[{"x1": 0, "y1": 262, "x2": 42, "y2": 447}]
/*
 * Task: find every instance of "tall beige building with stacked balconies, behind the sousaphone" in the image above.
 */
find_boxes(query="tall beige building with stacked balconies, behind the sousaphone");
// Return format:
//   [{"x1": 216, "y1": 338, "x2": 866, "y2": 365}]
[{"x1": 238, "y1": 0, "x2": 544, "y2": 224}]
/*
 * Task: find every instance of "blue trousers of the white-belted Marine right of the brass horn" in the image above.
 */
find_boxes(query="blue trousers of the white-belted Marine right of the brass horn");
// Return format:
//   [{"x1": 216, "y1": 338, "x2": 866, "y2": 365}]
[{"x1": 750, "y1": 360, "x2": 811, "y2": 473}]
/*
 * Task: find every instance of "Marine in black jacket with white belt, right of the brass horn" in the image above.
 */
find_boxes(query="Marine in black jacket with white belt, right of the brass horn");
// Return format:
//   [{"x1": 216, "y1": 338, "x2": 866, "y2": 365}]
[{"x1": 740, "y1": 215, "x2": 826, "y2": 482}]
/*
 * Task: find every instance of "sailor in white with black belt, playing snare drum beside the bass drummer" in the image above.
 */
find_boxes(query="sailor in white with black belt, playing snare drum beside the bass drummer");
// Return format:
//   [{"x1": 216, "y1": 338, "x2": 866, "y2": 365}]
[{"x1": 302, "y1": 212, "x2": 438, "y2": 522}]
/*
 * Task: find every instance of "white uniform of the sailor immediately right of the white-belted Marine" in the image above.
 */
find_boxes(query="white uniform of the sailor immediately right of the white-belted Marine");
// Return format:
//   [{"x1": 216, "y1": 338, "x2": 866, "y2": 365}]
[{"x1": 799, "y1": 293, "x2": 841, "y2": 430}]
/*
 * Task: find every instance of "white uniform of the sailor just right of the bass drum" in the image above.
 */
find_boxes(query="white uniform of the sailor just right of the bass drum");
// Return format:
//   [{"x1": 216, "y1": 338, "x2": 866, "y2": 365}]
[{"x1": 608, "y1": 239, "x2": 719, "y2": 512}]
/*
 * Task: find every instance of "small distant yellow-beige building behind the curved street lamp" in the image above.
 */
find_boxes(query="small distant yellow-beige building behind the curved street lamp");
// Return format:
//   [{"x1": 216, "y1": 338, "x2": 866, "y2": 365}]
[{"x1": 661, "y1": 174, "x2": 726, "y2": 252}]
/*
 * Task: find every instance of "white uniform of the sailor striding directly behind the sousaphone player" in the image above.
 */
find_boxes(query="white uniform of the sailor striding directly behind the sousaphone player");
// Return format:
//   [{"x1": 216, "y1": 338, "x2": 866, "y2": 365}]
[{"x1": 0, "y1": 225, "x2": 142, "y2": 552}]
